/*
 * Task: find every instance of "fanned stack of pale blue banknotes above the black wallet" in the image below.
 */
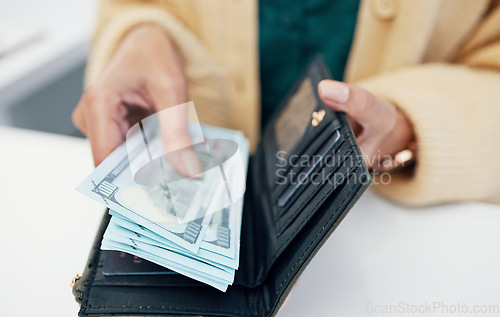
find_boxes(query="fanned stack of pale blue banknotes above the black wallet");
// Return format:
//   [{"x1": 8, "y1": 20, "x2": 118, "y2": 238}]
[{"x1": 77, "y1": 114, "x2": 249, "y2": 291}]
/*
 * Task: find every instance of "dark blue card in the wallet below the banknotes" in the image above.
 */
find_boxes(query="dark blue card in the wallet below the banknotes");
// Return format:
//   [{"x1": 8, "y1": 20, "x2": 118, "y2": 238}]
[{"x1": 101, "y1": 250, "x2": 177, "y2": 276}]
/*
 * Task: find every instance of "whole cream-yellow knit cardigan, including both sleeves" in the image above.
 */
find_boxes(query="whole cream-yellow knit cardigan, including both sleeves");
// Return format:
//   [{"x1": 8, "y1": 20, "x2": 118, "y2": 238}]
[{"x1": 86, "y1": 0, "x2": 500, "y2": 205}]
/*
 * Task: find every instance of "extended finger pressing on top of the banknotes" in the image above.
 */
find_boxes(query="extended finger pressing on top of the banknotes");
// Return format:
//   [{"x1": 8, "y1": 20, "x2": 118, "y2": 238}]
[{"x1": 150, "y1": 75, "x2": 202, "y2": 178}]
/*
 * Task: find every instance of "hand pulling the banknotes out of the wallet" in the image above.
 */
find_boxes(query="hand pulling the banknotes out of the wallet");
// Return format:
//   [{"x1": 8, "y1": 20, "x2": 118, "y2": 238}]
[{"x1": 73, "y1": 25, "x2": 201, "y2": 176}]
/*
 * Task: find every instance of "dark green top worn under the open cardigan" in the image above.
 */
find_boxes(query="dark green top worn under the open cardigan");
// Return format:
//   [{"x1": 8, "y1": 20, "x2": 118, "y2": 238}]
[{"x1": 259, "y1": 0, "x2": 359, "y2": 124}]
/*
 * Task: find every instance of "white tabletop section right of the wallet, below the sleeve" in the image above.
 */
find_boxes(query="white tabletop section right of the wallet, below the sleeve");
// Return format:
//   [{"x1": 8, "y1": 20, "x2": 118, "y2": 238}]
[{"x1": 279, "y1": 192, "x2": 500, "y2": 317}]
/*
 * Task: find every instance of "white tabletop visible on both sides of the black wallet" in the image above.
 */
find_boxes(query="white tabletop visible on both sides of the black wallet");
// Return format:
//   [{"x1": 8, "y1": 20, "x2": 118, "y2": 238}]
[{"x1": 0, "y1": 127, "x2": 500, "y2": 317}]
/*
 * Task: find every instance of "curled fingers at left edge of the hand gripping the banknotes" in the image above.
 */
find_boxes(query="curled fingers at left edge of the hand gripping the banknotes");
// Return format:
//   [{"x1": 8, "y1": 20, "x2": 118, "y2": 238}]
[{"x1": 72, "y1": 92, "x2": 127, "y2": 166}]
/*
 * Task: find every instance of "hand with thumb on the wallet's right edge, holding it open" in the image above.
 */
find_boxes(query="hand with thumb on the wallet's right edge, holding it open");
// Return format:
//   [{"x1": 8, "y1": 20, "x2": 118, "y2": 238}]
[{"x1": 318, "y1": 80, "x2": 415, "y2": 168}]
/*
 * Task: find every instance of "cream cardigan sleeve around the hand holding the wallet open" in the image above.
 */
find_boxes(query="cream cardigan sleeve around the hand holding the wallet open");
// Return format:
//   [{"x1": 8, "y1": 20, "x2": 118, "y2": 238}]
[{"x1": 359, "y1": 2, "x2": 500, "y2": 205}]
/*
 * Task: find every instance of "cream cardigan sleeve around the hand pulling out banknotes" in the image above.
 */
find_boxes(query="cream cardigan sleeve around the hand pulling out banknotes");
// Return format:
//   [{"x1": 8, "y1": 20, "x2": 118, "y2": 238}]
[{"x1": 85, "y1": 0, "x2": 228, "y2": 126}]
